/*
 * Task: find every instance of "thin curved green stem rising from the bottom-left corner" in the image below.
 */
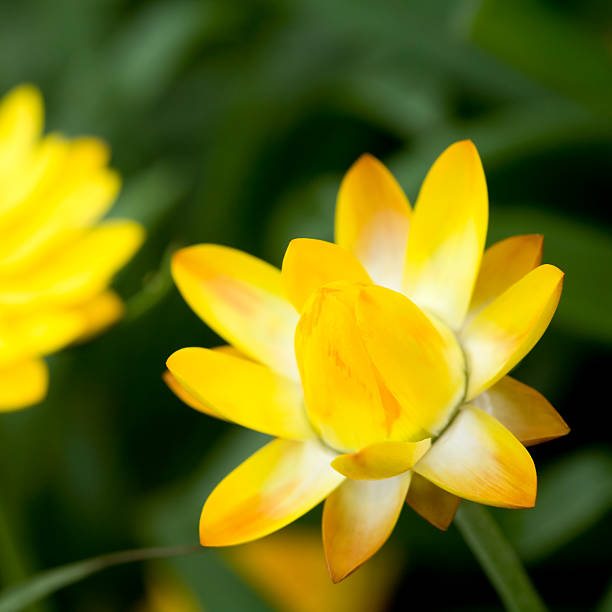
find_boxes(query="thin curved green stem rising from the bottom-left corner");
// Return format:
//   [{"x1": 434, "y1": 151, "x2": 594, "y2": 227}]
[{"x1": 0, "y1": 544, "x2": 204, "y2": 612}]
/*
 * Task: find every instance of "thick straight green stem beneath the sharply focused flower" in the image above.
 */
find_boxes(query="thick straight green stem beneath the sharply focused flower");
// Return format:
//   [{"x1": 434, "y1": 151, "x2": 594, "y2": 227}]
[{"x1": 455, "y1": 502, "x2": 546, "y2": 612}]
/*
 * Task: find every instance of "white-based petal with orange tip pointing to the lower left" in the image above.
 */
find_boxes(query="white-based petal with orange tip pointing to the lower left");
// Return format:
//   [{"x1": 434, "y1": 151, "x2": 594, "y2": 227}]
[{"x1": 200, "y1": 439, "x2": 344, "y2": 546}]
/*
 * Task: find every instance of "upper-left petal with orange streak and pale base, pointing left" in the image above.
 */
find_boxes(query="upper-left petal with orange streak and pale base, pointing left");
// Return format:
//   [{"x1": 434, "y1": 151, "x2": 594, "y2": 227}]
[{"x1": 172, "y1": 244, "x2": 298, "y2": 380}]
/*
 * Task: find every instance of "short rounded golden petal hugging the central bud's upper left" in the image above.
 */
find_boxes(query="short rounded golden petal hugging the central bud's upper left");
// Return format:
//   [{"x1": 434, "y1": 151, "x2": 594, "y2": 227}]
[{"x1": 282, "y1": 238, "x2": 372, "y2": 312}]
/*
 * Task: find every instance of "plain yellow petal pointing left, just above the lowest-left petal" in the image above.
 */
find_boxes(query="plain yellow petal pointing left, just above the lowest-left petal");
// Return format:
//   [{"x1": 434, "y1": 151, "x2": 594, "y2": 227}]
[{"x1": 166, "y1": 348, "x2": 314, "y2": 440}]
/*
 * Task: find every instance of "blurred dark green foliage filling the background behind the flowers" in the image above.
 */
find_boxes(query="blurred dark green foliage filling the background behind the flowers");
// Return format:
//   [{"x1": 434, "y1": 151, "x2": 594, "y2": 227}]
[{"x1": 0, "y1": 0, "x2": 612, "y2": 612}]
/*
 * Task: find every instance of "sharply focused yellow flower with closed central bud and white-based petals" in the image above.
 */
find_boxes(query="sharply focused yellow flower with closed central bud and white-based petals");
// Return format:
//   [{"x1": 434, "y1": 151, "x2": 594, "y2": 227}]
[{"x1": 167, "y1": 141, "x2": 568, "y2": 581}]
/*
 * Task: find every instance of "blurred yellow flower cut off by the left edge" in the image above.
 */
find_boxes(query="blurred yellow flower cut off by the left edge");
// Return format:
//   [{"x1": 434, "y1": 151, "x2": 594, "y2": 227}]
[{"x1": 0, "y1": 85, "x2": 143, "y2": 412}]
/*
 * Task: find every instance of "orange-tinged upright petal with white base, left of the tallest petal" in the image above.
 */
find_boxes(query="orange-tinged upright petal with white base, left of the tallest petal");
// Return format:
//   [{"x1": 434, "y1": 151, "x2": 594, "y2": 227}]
[{"x1": 336, "y1": 154, "x2": 410, "y2": 290}]
